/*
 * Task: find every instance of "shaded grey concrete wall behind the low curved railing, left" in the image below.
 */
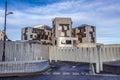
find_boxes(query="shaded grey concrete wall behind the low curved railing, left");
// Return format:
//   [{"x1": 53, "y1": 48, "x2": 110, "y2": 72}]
[{"x1": 0, "y1": 41, "x2": 49, "y2": 61}]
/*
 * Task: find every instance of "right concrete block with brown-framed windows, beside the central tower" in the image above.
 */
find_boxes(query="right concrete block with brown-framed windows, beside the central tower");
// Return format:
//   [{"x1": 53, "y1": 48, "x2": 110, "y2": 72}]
[{"x1": 73, "y1": 24, "x2": 96, "y2": 44}]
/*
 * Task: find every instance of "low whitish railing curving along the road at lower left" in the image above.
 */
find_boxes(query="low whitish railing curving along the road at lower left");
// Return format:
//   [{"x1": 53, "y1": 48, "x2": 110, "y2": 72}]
[{"x1": 0, "y1": 60, "x2": 49, "y2": 74}]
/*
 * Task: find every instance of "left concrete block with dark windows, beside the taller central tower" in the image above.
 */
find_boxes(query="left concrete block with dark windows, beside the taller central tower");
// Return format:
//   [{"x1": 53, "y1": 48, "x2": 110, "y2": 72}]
[{"x1": 21, "y1": 25, "x2": 52, "y2": 44}]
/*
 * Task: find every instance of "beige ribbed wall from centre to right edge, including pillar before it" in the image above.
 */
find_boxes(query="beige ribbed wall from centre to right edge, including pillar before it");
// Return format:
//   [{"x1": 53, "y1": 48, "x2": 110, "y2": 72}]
[{"x1": 49, "y1": 46, "x2": 120, "y2": 73}]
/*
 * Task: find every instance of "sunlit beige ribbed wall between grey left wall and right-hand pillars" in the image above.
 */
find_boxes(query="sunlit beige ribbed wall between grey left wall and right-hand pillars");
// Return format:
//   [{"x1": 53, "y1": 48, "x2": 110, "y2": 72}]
[{"x1": 49, "y1": 46, "x2": 98, "y2": 63}]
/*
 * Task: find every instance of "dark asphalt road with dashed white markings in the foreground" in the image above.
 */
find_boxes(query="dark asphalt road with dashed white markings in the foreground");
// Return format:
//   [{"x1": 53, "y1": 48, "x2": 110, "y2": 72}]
[{"x1": 0, "y1": 62, "x2": 120, "y2": 80}]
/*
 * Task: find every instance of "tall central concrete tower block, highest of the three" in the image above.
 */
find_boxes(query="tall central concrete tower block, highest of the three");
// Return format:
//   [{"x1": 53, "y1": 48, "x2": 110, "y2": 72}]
[{"x1": 52, "y1": 17, "x2": 77, "y2": 46}]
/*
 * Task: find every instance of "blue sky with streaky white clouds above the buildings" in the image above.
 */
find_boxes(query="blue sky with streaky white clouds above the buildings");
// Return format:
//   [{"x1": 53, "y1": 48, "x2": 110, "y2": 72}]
[{"x1": 0, "y1": 0, "x2": 120, "y2": 44}]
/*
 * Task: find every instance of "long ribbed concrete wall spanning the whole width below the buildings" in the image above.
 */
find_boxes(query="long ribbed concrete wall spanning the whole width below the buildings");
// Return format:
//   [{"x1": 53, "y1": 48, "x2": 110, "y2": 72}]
[{"x1": 0, "y1": 41, "x2": 120, "y2": 72}]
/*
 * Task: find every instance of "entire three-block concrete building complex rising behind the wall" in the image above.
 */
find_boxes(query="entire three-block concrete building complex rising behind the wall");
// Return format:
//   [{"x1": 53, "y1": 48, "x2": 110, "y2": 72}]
[{"x1": 22, "y1": 17, "x2": 96, "y2": 47}]
